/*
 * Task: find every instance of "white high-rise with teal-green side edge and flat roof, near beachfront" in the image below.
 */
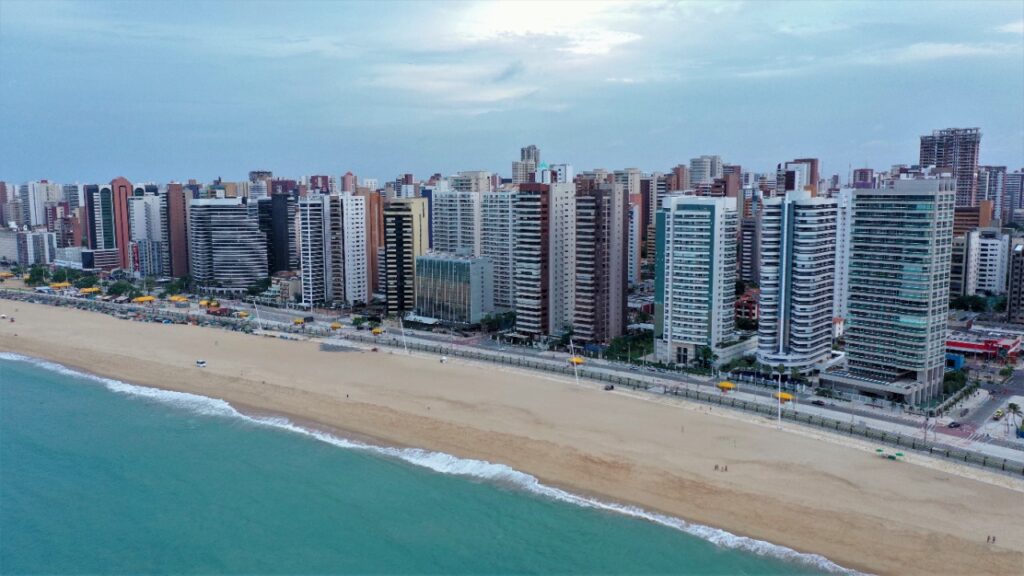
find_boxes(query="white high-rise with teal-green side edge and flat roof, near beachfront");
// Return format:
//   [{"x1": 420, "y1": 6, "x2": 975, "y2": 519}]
[{"x1": 654, "y1": 195, "x2": 737, "y2": 365}]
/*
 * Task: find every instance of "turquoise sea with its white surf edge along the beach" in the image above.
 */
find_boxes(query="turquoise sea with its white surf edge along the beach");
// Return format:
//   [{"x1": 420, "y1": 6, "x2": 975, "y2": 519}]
[{"x1": 0, "y1": 355, "x2": 839, "y2": 574}]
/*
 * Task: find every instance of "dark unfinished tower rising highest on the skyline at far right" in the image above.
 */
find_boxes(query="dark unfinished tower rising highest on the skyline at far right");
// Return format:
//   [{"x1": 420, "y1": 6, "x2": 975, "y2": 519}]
[{"x1": 920, "y1": 128, "x2": 981, "y2": 206}]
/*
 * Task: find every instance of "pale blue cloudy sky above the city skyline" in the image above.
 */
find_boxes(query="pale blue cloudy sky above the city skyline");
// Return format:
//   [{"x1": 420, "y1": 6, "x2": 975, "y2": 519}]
[{"x1": 0, "y1": 0, "x2": 1024, "y2": 182}]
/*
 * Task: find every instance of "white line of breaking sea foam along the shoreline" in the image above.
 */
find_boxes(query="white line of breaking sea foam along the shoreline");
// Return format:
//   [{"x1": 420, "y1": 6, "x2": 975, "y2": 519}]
[{"x1": 0, "y1": 353, "x2": 860, "y2": 574}]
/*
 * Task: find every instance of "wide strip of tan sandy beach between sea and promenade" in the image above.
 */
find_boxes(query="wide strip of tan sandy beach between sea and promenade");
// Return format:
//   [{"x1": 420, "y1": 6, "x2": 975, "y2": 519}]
[{"x1": 0, "y1": 300, "x2": 1024, "y2": 574}]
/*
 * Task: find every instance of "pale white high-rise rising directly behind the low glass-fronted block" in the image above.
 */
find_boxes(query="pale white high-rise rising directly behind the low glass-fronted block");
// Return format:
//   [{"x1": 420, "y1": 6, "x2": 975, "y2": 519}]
[{"x1": 429, "y1": 187, "x2": 481, "y2": 256}]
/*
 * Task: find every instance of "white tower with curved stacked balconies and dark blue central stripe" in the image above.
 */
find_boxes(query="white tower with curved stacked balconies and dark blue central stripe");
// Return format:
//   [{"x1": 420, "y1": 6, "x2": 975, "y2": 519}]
[{"x1": 758, "y1": 190, "x2": 837, "y2": 366}]
